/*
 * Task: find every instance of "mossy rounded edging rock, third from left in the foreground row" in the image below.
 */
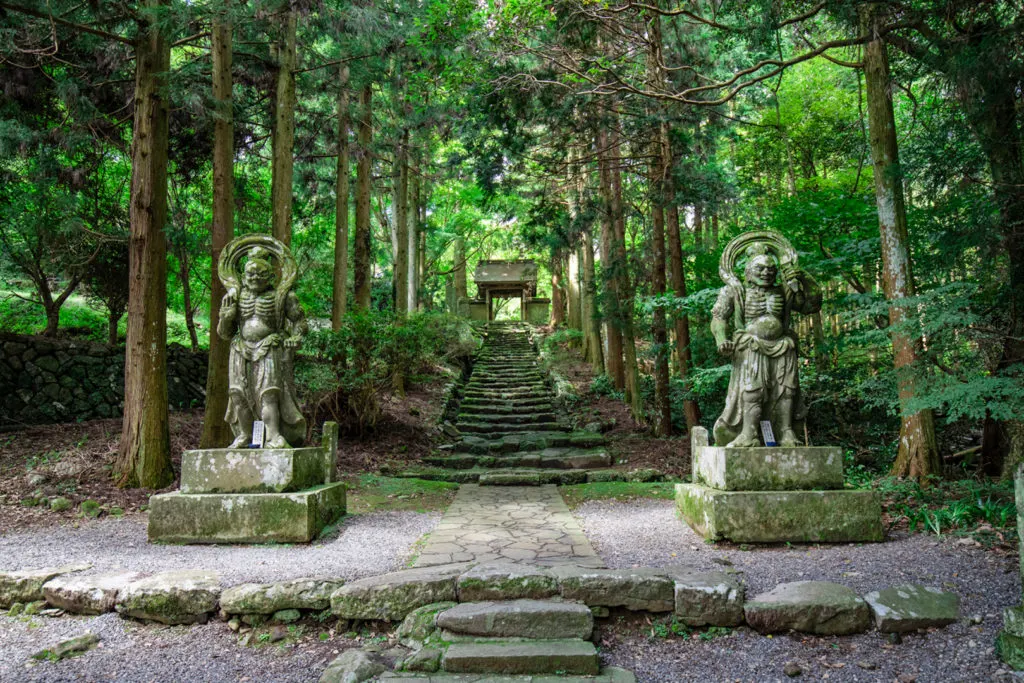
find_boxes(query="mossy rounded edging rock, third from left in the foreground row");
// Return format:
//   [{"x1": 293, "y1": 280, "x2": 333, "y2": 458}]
[{"x1": 117, "y1": 570, "x2": 220, "y2": 624}]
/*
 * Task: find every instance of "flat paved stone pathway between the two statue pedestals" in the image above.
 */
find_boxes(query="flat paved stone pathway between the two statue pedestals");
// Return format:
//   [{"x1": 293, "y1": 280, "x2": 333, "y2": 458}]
[{"x1": 414, "y1": 484, "x2": 604, "y2": 568}]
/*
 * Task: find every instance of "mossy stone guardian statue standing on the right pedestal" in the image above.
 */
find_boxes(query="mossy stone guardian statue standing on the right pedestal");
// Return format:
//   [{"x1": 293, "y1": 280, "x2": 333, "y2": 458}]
[{"x1": 711, "y1": 230, "x2": 821, "y2": 449}]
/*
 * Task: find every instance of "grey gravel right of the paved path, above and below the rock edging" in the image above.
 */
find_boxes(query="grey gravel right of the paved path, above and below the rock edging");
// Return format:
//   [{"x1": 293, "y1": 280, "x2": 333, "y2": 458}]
[{"x1": 575, "y1": 501, "x2": 1022, "y2": 683}]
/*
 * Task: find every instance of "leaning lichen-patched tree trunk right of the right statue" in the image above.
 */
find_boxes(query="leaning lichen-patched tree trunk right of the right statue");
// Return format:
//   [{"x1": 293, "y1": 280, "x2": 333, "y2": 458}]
[{"x1": 864, "y1": 10, "x2": 942, "y2": 479}]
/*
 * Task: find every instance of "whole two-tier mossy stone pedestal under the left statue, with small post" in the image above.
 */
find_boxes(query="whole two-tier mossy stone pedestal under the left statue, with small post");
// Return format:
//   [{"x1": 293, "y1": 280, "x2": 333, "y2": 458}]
[{"x1": 148, "y1": 422, "x2": 345, "y2": 544}]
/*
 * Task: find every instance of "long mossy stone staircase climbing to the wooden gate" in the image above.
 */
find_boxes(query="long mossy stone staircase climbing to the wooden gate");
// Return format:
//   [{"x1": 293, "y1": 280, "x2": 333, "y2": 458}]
[{"x1": 398, "y1": 323, "x2": 611, "y2": 485}]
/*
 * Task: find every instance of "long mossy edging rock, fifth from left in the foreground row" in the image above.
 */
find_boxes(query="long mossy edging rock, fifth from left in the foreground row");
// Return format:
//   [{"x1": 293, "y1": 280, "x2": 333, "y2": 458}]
[{"x1": 331, "y1": 563, "x2": 472, "y2": 622}]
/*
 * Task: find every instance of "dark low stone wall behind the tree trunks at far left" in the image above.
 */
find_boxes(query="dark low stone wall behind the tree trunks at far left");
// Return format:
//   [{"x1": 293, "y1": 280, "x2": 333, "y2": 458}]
[{"x1": 0, "y1": 333, "x2": 207, "y2": 429}]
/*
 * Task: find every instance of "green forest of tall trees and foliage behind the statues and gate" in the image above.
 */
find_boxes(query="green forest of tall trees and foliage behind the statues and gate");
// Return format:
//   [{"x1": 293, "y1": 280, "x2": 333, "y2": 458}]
[{"x1": 0, "y1": 0, "x2": 1024, "y2": 487}]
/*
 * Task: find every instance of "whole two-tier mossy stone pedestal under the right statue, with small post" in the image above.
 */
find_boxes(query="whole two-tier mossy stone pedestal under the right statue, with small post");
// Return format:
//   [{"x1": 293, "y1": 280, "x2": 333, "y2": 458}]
[{"x1": 676, "y1": 427, "x2": 883, "y2": 543}]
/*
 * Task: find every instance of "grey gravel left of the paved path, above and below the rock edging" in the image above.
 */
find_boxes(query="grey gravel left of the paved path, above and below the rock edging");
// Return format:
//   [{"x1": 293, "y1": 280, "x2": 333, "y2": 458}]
[{"x1": 0, "y1": 512, "x2": 440, "y2": 683}]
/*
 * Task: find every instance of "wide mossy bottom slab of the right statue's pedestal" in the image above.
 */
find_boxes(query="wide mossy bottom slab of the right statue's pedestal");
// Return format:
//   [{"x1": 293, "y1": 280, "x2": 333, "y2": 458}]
[{"x1": 676, "y1": 483, "x2": 885, "y2": 543}]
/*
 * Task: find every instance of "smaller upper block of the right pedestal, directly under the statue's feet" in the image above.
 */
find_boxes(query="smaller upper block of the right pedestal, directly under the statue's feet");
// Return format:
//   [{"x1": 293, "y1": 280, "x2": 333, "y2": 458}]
[{"x1": 693, "y1": 445, "x2": 843, "y2": 490}]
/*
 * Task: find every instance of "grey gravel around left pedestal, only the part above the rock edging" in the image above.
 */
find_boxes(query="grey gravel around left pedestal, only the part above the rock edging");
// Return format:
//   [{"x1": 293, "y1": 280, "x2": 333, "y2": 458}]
[{"x1": 0, "y1": 512, "x2": 440, "y2": 586}]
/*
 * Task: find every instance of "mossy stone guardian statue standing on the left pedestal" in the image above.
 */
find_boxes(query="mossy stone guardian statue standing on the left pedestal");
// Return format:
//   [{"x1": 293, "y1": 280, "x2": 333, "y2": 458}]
[{"x1": 217, "y1": 234, "x2": 307, "y2": 449}]
